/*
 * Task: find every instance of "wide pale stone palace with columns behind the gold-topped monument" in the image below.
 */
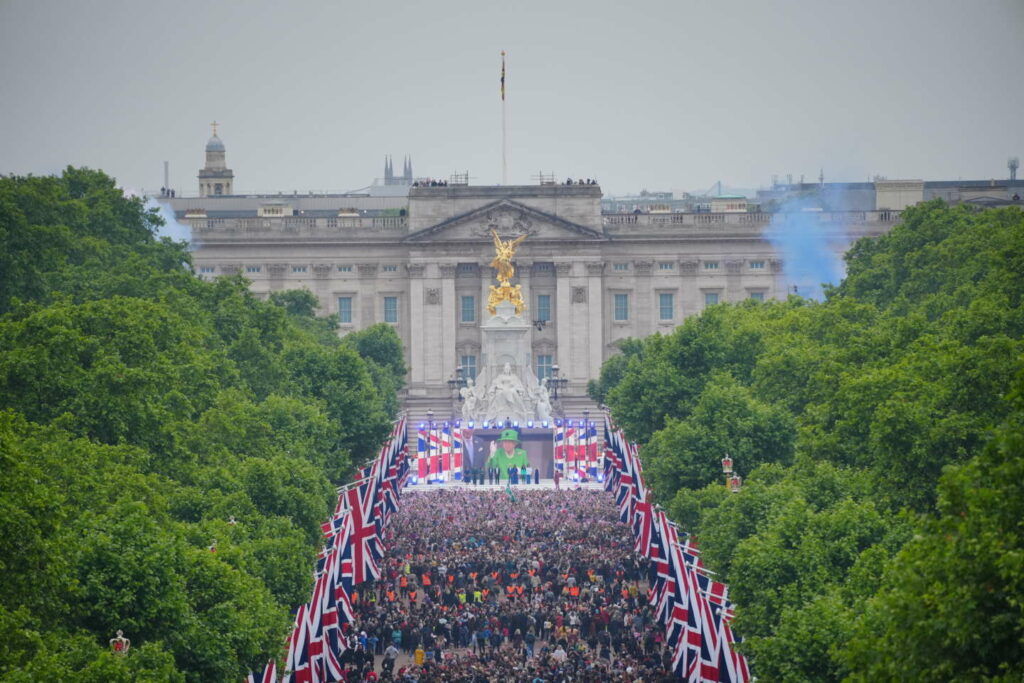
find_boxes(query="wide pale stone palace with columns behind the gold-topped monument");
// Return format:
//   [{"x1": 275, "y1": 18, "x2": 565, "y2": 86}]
[{"x1": 165, "y1": 131, "x2": 898, "y2": 414}]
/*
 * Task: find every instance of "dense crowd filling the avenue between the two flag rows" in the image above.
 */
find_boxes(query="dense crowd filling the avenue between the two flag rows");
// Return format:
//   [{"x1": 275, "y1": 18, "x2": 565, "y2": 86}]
[{"x1": 329, "y1": 487, "x2": 677, "y2": 683}]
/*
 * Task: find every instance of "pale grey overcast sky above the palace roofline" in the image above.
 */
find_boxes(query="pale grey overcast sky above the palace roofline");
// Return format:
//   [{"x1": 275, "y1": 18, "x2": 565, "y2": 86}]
[{"x1": 0, "y1": 0, "x2": 1024, "y2": 195}]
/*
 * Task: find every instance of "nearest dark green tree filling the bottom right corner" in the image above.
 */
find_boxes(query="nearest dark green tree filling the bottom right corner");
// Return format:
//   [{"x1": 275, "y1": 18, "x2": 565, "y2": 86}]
[{"x1": 842, "y1": 380, "x2": 1024, "y2": 681}]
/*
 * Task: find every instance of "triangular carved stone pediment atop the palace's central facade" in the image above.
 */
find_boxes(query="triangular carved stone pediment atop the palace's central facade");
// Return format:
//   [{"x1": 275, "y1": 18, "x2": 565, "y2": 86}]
[{"x1": 404, "y1": 199, "x2": 607, "y2": 242}]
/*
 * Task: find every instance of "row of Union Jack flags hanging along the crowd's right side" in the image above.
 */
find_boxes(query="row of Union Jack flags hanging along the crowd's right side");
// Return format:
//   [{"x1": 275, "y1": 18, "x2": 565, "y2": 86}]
[{"x1": 604, "y1": 415, "x2": 751, "y2": 683}]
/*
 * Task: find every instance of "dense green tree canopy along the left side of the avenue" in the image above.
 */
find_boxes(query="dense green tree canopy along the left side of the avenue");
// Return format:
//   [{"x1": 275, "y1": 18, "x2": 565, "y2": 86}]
[{"x1": 0, "y1": 168, "x2": 404, "y2": 682}]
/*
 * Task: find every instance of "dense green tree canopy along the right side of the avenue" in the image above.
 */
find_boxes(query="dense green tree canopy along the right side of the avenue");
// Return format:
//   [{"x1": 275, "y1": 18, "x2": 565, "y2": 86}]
[{"x1": 591, "y1": 201, "x2": 1024, "y2": 681}]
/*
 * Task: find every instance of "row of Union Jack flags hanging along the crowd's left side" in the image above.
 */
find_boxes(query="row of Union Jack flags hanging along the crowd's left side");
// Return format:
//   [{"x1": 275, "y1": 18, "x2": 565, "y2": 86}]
[{"x1": 247, "y1": 418, "x2": 410, "y2": 683}]
